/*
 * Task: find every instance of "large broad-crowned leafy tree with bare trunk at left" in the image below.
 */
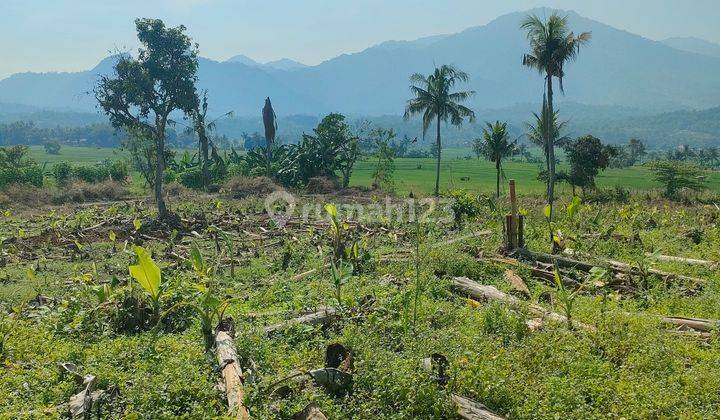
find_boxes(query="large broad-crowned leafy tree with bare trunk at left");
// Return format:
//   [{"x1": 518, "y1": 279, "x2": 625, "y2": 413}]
[{"x1": 95, "y1": 19, "x2": 198, "y2": 220}]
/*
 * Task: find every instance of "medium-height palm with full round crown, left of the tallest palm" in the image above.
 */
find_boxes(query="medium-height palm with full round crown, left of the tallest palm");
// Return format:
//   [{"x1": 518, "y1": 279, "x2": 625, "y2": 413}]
[{"x1": 404, "y1": 65, "x2": 475, "y2": 197}]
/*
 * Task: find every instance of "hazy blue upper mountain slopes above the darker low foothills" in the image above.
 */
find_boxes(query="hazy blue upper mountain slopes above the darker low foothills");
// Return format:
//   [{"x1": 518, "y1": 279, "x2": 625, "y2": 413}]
[{"x1": 0, "y1": 9, "x2": 720, "y2": 116}]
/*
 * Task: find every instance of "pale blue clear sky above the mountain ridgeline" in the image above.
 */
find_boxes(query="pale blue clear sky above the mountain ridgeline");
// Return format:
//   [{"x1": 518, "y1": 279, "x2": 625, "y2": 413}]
[{"x1": 0, "y1": 0, "x2": 720, "y2": 79}]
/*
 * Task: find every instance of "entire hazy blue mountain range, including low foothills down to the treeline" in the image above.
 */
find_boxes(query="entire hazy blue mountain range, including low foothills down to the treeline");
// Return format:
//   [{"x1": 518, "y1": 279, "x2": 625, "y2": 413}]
[{"x1": 0, "y1": 9, "x2": 720, "y2": 149}]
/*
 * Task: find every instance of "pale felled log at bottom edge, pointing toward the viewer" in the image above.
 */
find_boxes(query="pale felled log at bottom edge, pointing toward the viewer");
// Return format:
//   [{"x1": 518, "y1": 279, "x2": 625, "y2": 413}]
[{"x1": 215, "y1": 330, "x2": 249, "y2": 420}]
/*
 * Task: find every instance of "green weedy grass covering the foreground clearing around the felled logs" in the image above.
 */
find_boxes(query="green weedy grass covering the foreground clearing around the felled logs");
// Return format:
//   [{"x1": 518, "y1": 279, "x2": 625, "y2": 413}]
[{"x1": 0, "y1": 189, "x2": 720, "y2": 419}]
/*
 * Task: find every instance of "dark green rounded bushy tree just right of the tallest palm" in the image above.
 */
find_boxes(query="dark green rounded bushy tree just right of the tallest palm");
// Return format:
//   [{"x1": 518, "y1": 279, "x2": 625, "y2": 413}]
[{"x1": 565, "y1": 134, "x2": 617, "y2": 195}]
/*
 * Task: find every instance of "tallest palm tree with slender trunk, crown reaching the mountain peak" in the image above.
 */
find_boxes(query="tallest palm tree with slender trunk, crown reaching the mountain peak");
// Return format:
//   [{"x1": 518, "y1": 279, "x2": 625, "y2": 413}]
[{"x1": 520, "y1": 13, "x2": 590, "y2": 226}]
